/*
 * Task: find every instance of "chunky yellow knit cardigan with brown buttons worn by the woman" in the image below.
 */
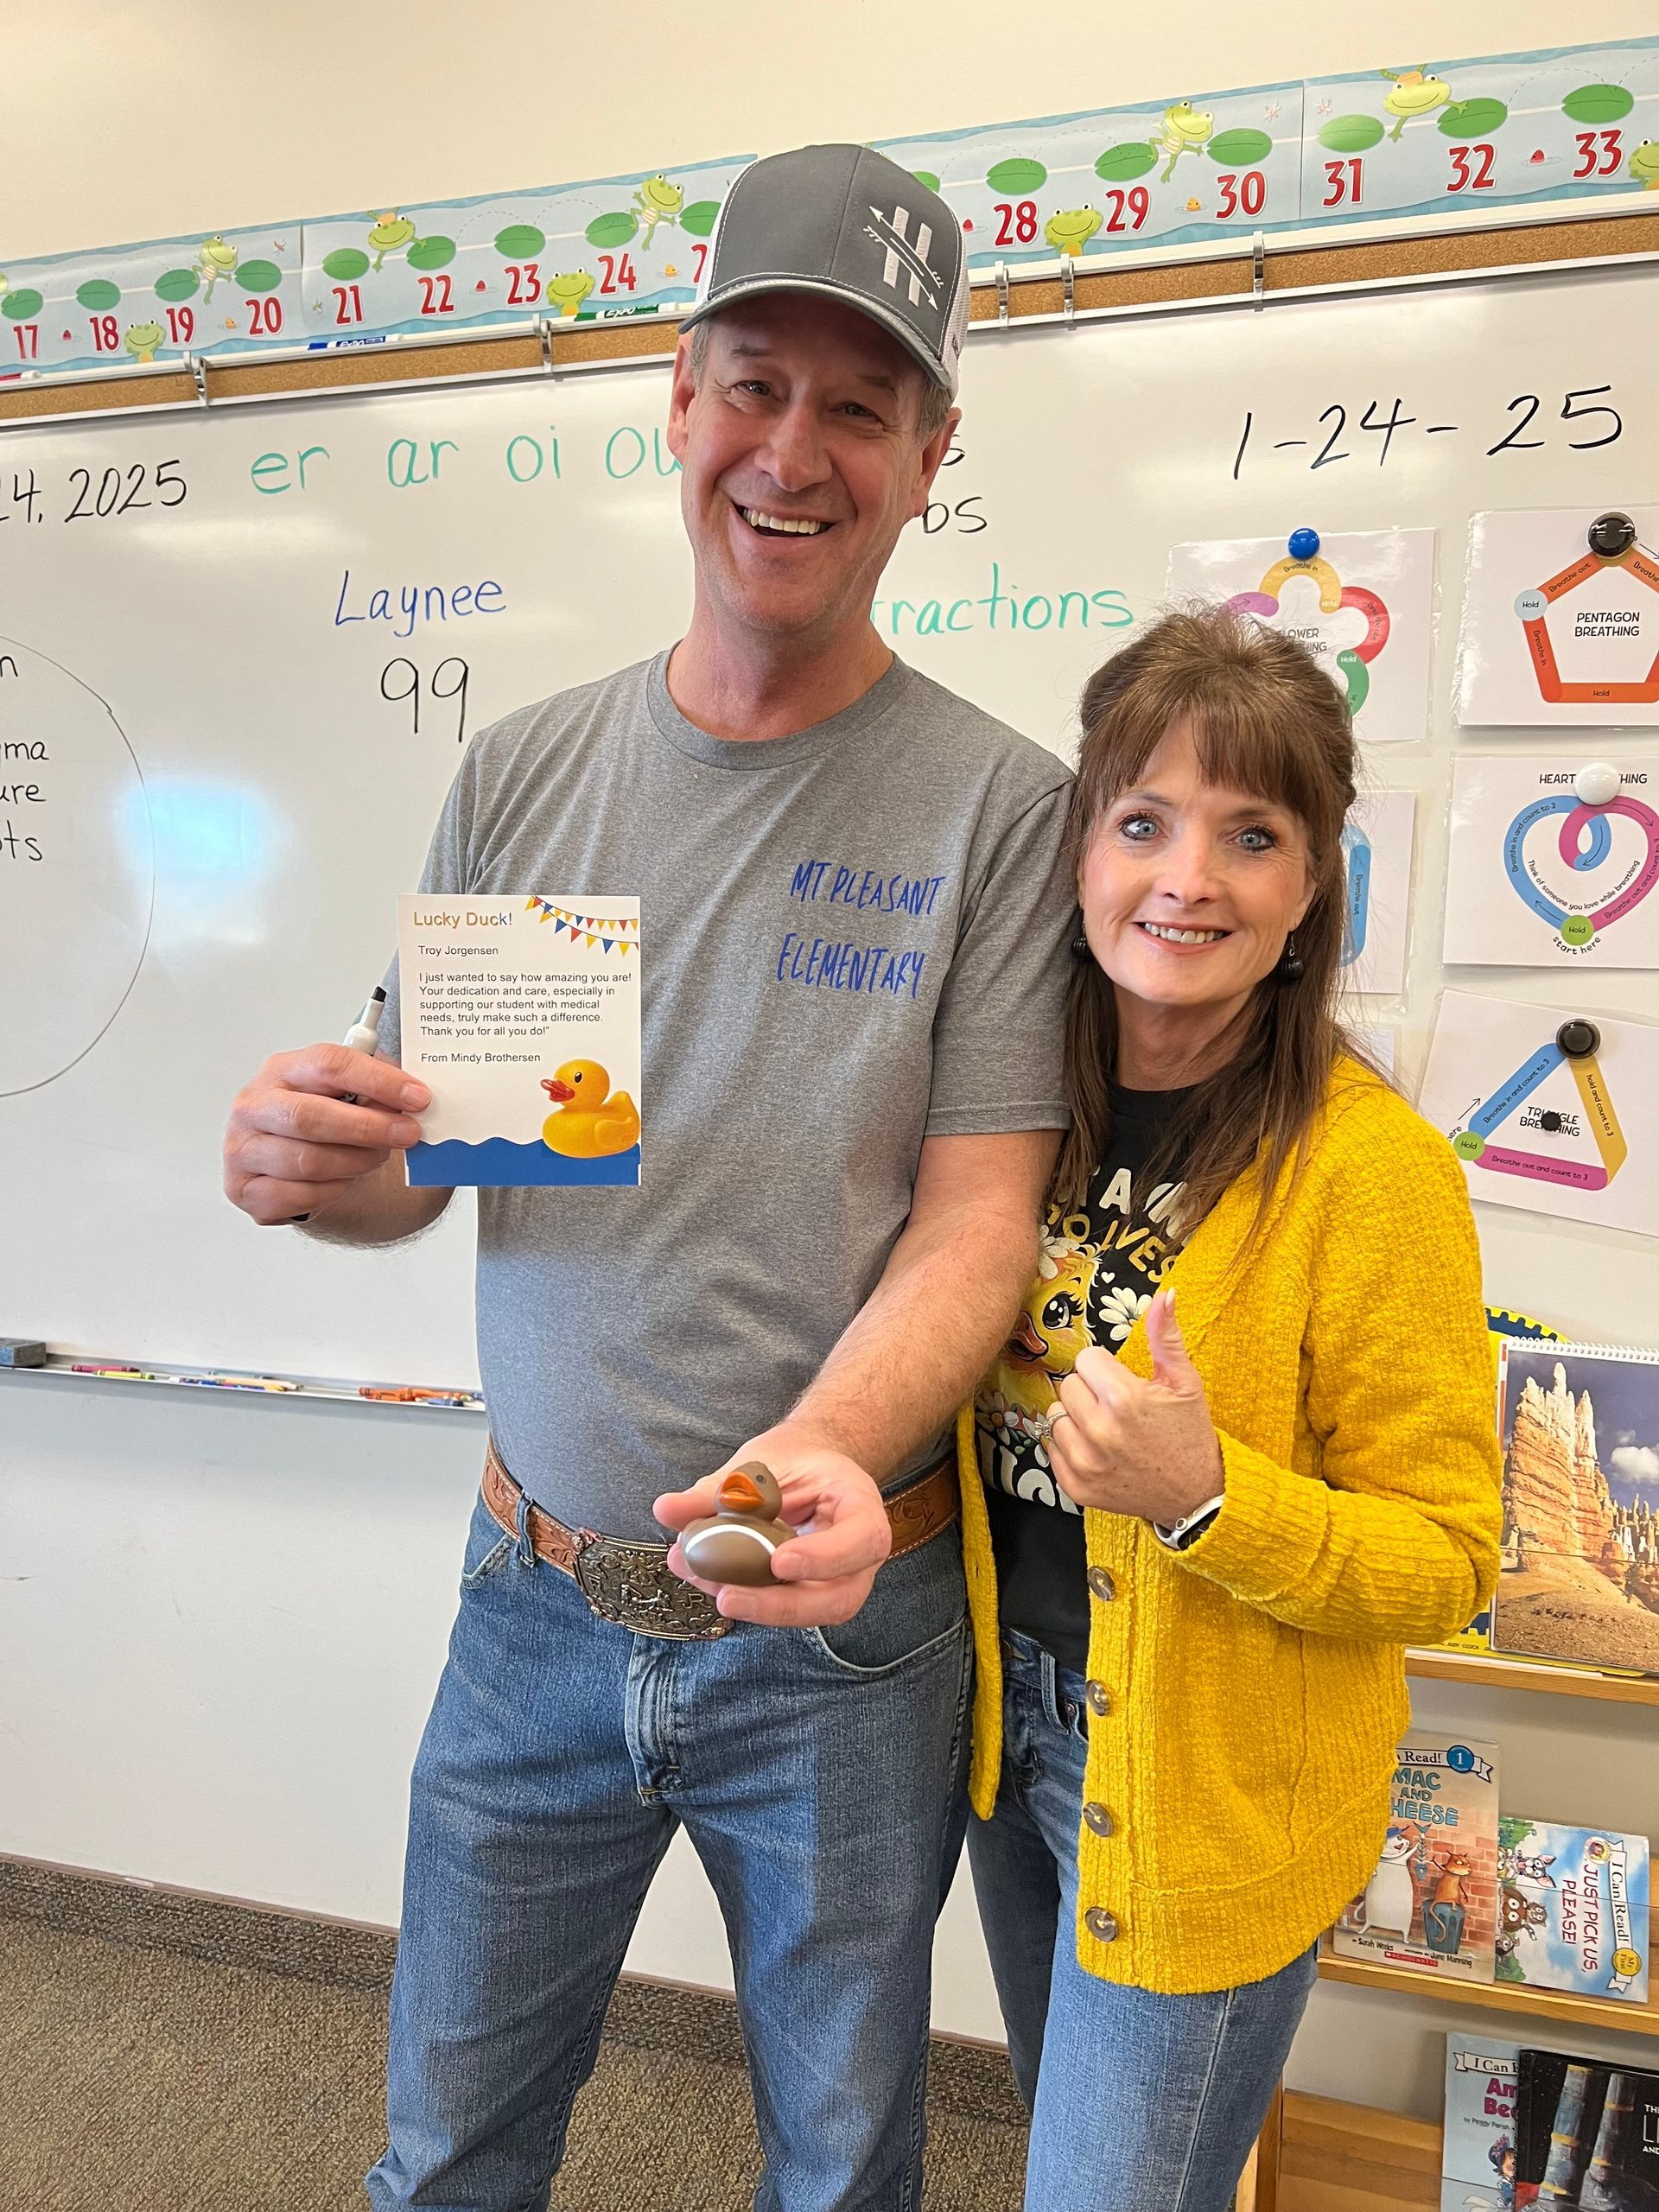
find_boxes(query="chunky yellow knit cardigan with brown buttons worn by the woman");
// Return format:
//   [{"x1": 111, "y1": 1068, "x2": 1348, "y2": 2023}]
[{"x1": 957, "y1": 1062, "x2": 1500, "y2": 1993}]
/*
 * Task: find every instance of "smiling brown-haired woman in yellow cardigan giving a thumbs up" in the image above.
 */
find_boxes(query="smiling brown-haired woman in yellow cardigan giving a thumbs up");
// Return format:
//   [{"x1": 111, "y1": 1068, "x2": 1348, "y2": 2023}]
[{"x1": 963, "y1": 613, "x2": 1497, "y2": 2212}]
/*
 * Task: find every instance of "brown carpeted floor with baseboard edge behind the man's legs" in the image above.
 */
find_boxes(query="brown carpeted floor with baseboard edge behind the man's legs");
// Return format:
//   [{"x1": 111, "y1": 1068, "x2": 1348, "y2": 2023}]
[{"x1": 0, "y1": 1865, "x2": 1024, "y2": 2212}]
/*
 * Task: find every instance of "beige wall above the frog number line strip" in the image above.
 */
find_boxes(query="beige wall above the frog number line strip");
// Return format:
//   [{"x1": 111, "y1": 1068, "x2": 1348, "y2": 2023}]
[{"x1": 13, "y1": 0, "x2": 1659, "y2": 268}]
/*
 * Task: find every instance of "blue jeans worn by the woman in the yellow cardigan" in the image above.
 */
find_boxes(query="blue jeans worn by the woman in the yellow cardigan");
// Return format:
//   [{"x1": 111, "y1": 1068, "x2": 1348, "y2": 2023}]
[{"x1": 969, "y1": 1635, "x2": 1314, "y2": 2212}]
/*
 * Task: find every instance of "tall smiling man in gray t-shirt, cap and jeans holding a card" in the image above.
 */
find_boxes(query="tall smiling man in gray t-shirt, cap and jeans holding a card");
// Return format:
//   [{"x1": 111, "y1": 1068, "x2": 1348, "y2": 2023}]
[{"x1": 226, "y1": 146, "x2": 1073, "y2": 2212}]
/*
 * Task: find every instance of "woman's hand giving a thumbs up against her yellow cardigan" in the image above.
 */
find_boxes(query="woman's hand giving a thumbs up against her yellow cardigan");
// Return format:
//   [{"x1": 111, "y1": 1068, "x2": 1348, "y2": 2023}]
[{"x1": 1048, "y1": 1289, "x2": 1224, "y2": 1526}]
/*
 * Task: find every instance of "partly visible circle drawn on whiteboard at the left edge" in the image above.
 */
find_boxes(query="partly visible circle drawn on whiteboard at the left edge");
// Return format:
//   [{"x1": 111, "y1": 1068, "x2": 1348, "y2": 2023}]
[{"x1": 0, "y1": 637, "x2": 155, "y2": 1097}]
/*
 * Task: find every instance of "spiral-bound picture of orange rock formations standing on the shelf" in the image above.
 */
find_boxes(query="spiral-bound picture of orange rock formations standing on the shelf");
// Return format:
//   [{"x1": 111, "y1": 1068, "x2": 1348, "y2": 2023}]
[{"x1": 1491, "y1": 1340, "x2": 1659, "y2": 1675}]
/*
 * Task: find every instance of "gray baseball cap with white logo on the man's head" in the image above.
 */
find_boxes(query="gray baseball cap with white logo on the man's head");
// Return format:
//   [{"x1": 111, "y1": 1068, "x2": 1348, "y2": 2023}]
[{"x1": 679, "y1": 146, "x2": 969, "y2": 398}]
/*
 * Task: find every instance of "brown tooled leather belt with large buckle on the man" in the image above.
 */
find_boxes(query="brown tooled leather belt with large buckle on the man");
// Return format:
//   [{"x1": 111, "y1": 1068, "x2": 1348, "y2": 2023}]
[{"x1": 482, "y1": 1438, "x2": 960, "y2": 1642}]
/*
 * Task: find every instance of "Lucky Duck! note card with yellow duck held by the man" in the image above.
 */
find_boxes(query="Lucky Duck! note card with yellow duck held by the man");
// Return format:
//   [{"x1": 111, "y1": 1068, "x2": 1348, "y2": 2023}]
[{"x1": 398, "y1": 892, "x2": 641, "y2": 1188}]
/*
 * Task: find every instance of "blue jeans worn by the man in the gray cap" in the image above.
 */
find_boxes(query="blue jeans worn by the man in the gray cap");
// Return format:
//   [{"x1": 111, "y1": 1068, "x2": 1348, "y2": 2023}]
[{"x1": 367, "y1": 1502, "x2": 971, "y2": 2212}]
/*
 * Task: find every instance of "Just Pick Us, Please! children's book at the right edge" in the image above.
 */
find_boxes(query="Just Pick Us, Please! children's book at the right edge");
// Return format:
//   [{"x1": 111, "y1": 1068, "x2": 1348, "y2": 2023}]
[{"x1": 1497, "y1": 1814, "x2": 1648, "y2": 2004}]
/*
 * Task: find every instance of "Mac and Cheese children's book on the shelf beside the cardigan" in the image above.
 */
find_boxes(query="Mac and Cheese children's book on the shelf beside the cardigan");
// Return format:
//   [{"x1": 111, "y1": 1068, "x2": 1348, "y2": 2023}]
[{"x1": 1332, "y1": 1727, "x2": 1497, "y2": 1982}]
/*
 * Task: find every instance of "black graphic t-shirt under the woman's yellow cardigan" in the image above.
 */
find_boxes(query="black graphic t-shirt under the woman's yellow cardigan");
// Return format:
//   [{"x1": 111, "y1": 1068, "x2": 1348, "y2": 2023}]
[{"x1": 973, "y1": 1084, "x2": 1185, "y2": 1675}]
